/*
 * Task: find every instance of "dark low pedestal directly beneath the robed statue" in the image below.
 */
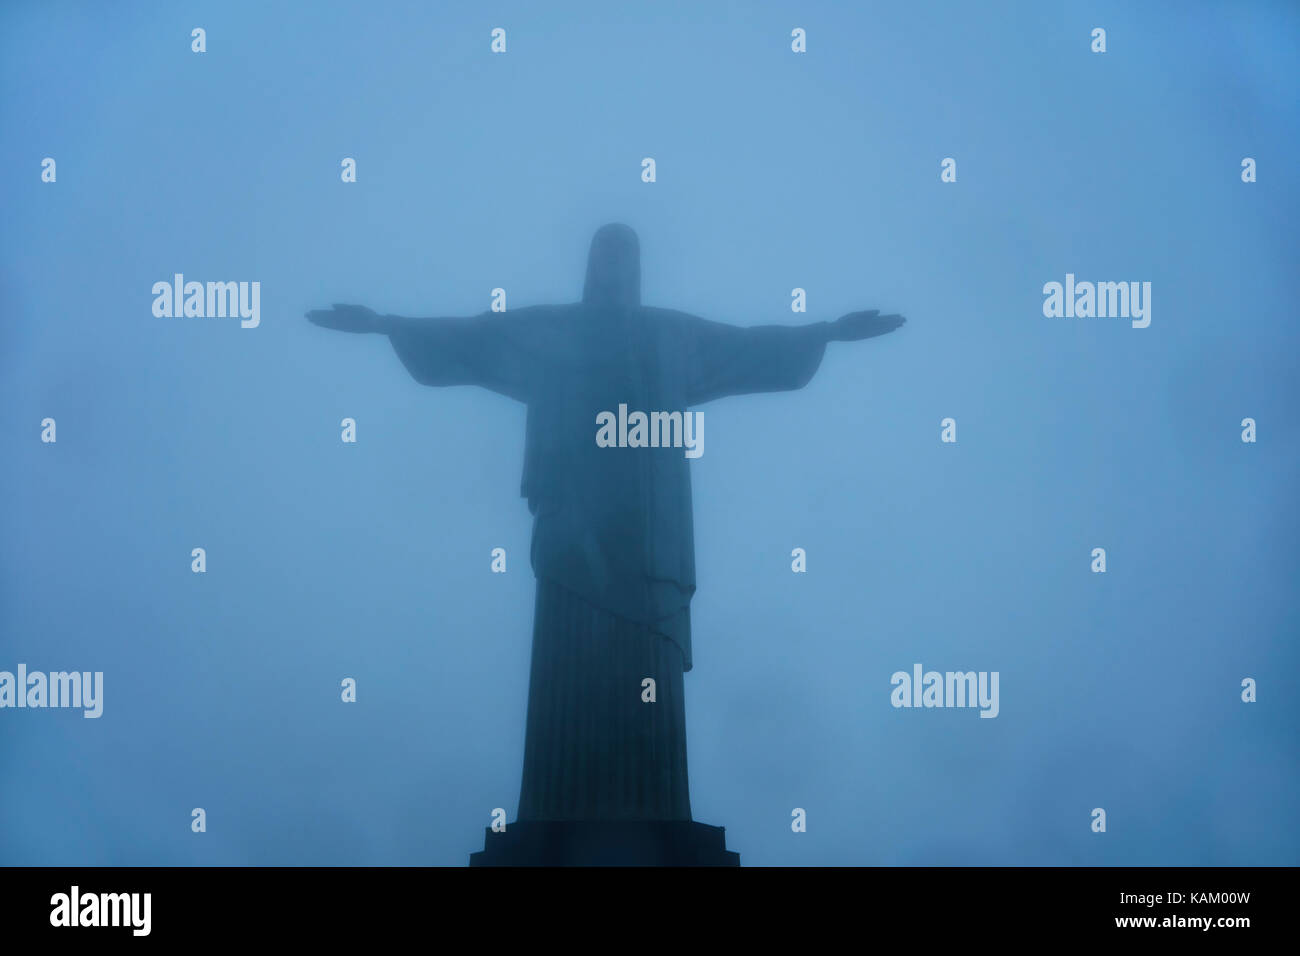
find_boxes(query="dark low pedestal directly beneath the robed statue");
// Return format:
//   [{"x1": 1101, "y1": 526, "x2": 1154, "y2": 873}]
[{"x1": 469, "y1": 819, "x2": 740, "y2": 866}]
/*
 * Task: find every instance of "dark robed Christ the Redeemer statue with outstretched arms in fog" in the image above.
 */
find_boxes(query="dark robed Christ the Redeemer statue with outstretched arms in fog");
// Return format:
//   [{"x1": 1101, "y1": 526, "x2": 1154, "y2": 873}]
[{"x1": 308, "y1": 225, "x2": 904, "y2": 862}]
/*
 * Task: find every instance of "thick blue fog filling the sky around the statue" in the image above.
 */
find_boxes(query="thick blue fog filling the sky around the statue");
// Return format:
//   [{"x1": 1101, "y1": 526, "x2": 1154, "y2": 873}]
[{"x1": 0, "y1": 3, "x2": 1300, "y2": 866}]
